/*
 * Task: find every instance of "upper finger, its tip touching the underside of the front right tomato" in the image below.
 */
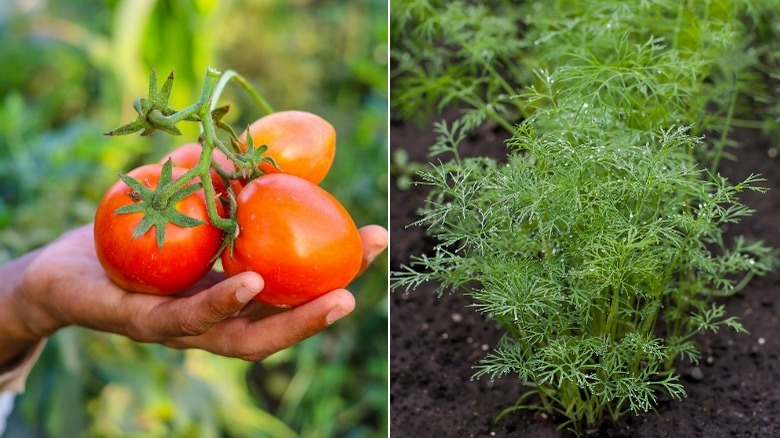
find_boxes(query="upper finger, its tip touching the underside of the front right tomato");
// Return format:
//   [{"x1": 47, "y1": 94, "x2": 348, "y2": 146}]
[{"x1": 134, "y1": 271, "x2": 264, "y2": 341}]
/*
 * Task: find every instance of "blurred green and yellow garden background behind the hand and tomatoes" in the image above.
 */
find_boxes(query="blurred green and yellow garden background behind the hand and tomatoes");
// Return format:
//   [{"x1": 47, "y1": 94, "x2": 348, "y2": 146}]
[{"x1": 0, "y1": 0, "x2": 388, "y2": 437}]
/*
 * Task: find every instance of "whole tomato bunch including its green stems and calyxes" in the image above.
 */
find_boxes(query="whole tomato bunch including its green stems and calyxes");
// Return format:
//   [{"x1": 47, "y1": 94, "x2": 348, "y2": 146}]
[{"x1": 95, "y1": 68, "x2": 362, "y2": 307}]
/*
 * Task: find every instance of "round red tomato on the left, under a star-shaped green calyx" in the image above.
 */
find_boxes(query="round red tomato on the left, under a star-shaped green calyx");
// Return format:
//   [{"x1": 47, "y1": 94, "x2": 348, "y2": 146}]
[{"x1": 95, "y1": 164, "x2": 223, "y2": 295}]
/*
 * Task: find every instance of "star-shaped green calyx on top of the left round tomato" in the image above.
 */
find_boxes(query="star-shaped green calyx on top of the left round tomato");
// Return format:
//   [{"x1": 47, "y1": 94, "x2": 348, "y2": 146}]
[{"x1": 114, "y1": 160, "x2": 204, "y2": 249}]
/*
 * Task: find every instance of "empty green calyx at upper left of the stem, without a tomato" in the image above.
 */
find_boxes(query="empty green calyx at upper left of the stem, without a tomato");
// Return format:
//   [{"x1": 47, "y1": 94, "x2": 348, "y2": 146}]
[{"x1": 104, "y1": 69, "x2": 200, "y2": 136}]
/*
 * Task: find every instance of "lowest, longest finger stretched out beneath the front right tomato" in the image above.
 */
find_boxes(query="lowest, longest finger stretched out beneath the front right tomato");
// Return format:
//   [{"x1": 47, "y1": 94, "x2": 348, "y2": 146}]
[{"x1": 169, "y1": 289, "x2": 355, "y2": 361}]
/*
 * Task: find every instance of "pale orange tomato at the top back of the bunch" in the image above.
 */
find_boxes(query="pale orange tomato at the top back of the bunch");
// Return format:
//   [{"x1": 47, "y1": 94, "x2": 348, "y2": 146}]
[{"x1": 239, "y1": 111, "x2": 336, "y2": 184}]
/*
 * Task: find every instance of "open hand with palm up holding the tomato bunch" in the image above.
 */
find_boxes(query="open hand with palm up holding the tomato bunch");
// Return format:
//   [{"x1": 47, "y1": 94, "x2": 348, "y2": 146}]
[{"x1": 0, "y1": 224, "x2": 388, "y2": 363}]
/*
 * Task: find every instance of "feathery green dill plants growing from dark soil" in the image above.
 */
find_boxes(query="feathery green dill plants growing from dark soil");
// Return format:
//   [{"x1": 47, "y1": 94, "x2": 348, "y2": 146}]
[{"x1": 393, "y1": 0, "x2": 775, "y2": 434}]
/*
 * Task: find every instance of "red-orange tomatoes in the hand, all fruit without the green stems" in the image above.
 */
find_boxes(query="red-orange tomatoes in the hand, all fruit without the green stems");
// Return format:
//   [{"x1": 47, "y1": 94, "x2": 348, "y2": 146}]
[{"x1": 95, "y1": 111, "x2": 362, "y2": 307}]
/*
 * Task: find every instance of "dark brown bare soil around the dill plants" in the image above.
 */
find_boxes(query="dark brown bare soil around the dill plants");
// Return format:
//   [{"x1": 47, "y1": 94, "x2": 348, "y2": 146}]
[{"x1": 390, "y1": 113, "x2": 780, "y2": 438}]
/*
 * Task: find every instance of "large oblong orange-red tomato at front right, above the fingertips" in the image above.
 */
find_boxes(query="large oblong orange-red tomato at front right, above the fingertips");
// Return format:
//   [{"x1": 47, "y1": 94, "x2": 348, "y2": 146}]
[{"x1": 222, "y1": 173, "x2": 362, "y2": 307}]
